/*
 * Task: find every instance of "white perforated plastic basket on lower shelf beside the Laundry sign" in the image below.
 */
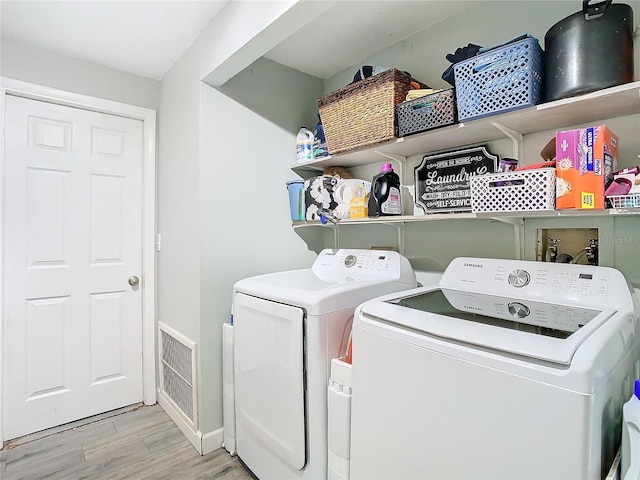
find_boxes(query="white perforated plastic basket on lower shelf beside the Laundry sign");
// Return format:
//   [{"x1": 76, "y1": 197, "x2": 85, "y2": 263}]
[{"x1": 470, "y1": 168, "x2": 556, "y2": 212}]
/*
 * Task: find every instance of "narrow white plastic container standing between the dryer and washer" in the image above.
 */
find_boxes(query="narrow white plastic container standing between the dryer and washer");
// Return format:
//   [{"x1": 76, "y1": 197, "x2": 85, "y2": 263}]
[{"x1": 327, "y1": 358, "x2": 351, "y2": 480}]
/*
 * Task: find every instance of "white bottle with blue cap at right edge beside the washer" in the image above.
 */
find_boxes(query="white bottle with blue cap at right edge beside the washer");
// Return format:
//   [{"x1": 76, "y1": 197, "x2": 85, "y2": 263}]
[{"x1": 620, "y1": 379, "x2": 640, "y2": 480}]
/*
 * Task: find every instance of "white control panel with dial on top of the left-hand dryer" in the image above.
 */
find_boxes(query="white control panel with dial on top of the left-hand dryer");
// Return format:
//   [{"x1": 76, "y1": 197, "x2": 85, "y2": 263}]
[{"x1": 311, "y1": 249, "x2": 416, "y2": 283}]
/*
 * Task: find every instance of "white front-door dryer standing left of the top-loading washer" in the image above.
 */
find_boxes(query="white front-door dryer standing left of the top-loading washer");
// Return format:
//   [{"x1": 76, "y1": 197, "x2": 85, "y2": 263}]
[{"x1": 233, "y1": 249, "x2": 417, "y2": 480}]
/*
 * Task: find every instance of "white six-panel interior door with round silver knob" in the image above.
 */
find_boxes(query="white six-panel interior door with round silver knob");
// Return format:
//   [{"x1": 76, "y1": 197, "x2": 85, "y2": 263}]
[{"x1": 3, "y1": 95, "x2": 143, "y2": 439}]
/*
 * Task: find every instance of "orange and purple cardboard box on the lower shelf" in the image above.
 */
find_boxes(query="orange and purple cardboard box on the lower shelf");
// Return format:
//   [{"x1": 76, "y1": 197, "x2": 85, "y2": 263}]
[{"x1": 556, "y1": 125, "x2": 618, "y2": 210}]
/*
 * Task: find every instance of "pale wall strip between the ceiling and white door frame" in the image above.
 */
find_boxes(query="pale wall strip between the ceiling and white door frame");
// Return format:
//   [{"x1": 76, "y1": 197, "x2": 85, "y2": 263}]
[{"x1": 1, "y1": 38, "x2": 160, "y2": 110}]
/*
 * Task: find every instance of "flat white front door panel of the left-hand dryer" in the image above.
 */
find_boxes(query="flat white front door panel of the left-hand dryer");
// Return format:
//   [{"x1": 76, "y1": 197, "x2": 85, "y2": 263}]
[{"x1": 233, "y1": 293, "x2": 306, "y2": 468}]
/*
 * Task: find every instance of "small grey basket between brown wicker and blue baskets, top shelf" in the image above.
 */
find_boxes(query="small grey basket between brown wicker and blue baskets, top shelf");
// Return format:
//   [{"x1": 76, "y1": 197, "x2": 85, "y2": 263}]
[{"x1": 396, "y1": 88, "x2": 458, "y2": 137}]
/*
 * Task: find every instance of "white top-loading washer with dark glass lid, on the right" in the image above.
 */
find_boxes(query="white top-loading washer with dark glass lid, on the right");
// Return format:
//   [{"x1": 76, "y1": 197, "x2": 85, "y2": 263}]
[{"x1": 350, "y1": 258, "x2": 640, "y2": 480}]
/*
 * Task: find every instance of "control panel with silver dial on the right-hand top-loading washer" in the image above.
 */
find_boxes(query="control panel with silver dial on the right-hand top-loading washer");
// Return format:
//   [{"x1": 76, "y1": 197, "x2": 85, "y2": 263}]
[{"x1": 440, "y1": 257, "x2": 630, "y2": 306}]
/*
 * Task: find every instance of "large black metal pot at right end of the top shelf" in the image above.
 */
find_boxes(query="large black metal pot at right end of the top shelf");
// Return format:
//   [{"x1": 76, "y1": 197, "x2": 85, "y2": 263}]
[{"x1": 544, "y1": 0, "x2": 633, "y2": 101}]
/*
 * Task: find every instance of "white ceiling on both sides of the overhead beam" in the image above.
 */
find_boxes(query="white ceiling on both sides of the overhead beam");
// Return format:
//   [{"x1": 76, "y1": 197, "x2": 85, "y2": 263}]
[{"x1": 0, "y1": 0, "x2": 478, "y2": 80}]
